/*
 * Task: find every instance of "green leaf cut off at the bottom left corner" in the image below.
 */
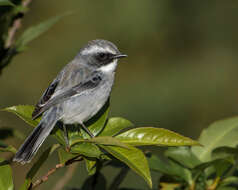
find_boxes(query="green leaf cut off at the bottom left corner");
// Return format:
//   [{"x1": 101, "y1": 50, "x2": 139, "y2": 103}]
[{"x1": 0, "y1": 158, "x2": 14, "y2": 190}]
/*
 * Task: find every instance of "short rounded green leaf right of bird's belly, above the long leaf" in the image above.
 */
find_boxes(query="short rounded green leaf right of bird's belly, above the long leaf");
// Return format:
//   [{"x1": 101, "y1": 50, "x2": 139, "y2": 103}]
[{"x1": 99, "y1": 117, "x2": 133, "y2": 136}]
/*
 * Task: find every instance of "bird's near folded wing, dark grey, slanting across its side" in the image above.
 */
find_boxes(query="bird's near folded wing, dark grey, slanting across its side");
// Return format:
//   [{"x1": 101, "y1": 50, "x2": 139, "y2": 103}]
[{"x1": 30, "y1": 72, "x2": 102, "y2": 118}]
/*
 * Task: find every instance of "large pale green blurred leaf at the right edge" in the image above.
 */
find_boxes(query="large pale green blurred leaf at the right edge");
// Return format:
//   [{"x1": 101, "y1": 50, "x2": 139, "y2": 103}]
[{"x1": 192, "y1": 117, "x2": 238, "y2": 162}]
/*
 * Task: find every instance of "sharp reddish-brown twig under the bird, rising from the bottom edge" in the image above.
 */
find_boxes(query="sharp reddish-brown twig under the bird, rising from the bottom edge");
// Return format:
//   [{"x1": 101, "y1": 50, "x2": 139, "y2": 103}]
[{"x1": 29, "y1": 156, "x2": 83, "y2": 189}]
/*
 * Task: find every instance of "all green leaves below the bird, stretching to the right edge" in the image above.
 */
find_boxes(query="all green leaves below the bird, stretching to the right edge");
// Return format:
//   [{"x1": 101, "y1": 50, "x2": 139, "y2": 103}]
[{"x1": 1, "y1": 105, "x2": 238, "y2": 190}]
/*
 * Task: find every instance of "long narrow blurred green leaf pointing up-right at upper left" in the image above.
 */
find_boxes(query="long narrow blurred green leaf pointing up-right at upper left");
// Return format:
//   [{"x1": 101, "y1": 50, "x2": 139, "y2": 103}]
[{"x1": 16, "y1": 12, "x2": 71, "y2": 51}]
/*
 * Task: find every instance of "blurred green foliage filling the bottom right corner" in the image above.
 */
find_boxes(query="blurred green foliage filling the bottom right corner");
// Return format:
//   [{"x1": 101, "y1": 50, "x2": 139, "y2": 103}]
[{"x1": 149, "y1": 117, "x2": 238, "y2": 190}]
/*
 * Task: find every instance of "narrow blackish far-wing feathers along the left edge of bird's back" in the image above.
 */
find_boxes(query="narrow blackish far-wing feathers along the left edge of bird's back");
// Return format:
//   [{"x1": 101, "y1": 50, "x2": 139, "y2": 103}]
[{"x1": 32, "y1": 78, "x2": 59, "y2": 119}]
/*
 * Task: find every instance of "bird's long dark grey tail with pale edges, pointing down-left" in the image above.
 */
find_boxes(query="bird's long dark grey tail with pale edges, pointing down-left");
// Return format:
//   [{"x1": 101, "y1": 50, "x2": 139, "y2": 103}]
[{"x1": 13, "y1": 110, "x2": 57, "y2": 164}]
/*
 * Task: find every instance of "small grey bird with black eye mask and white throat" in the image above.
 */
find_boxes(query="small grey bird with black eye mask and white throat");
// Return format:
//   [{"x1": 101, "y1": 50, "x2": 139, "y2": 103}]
[{"x1": 13, "y1": 39, "x2": 127, "y2": 164}]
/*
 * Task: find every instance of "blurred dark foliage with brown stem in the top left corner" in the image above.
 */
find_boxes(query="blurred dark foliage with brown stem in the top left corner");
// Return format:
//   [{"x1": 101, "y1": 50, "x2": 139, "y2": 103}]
[{"x1": 0, "y1": 0, "x2": 69, "y2": 73}]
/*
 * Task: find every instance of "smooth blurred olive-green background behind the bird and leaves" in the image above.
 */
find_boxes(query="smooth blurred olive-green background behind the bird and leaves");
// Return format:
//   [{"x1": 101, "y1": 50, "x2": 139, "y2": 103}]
[{"x1": 0, "y1": 0, "x2": 238, "y2": 189}]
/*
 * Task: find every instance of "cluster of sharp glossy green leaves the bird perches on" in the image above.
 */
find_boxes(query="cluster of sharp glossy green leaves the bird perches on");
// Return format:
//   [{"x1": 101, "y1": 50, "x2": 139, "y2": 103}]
[{"x1": 0, "y1": 105, "x2": 199, "y2": 190}]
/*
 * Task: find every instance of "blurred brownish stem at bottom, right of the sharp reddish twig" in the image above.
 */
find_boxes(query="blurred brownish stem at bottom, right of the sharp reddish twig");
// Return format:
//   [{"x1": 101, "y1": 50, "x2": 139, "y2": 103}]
[{"x1": 52, "y1": 163, "x2": 78, "y2": 190}]
